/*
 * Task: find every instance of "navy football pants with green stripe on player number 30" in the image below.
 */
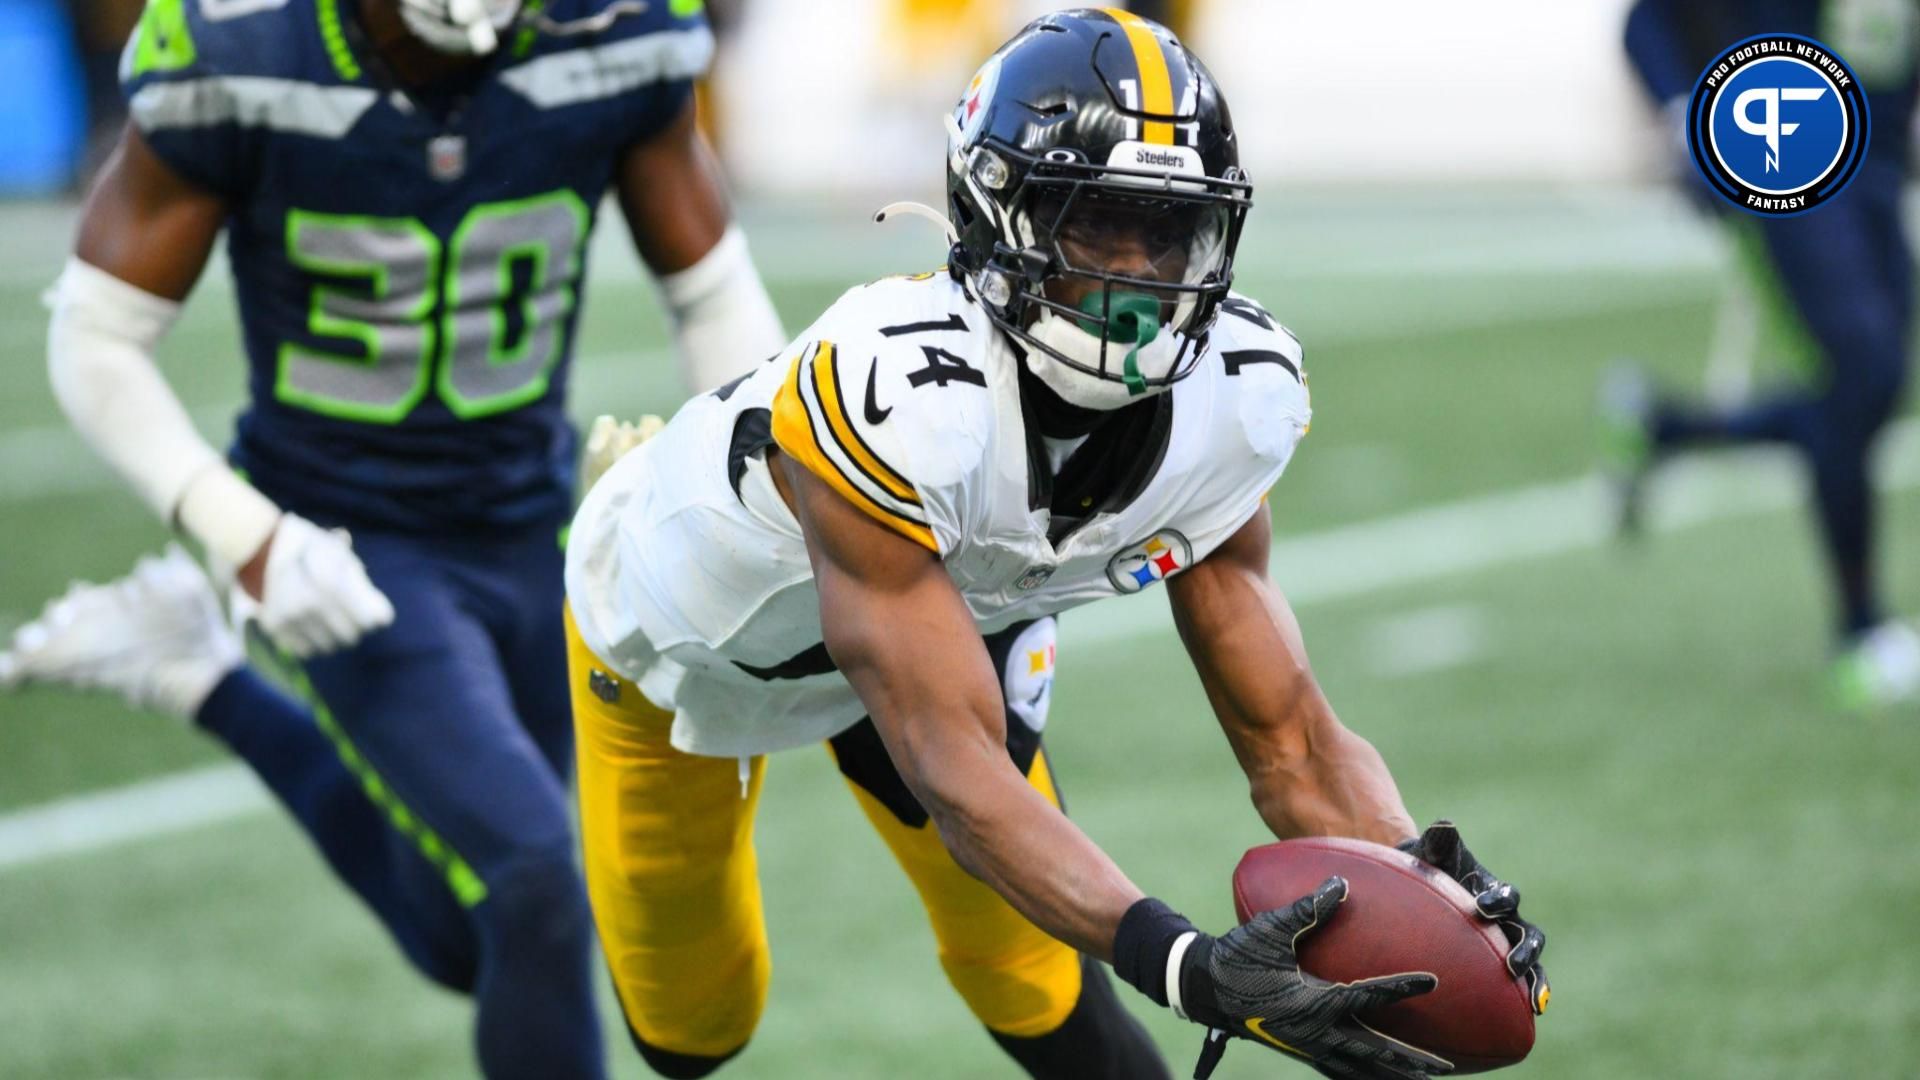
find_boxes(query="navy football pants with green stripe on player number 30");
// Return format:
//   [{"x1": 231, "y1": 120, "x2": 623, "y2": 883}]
[{"x1": 198, "y1": 527, "x2": 603, "y2": 1078}]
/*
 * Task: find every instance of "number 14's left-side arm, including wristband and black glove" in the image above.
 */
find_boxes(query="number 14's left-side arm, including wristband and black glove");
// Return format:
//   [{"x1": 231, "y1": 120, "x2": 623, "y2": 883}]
[{"x1": 774, "y1": 455, "x2": 1446, "y2": 1080}]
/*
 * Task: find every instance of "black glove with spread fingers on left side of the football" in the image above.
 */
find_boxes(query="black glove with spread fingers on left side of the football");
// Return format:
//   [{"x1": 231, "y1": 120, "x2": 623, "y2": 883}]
[{"x1": 1177, "y1": 876, "x2": 1453, "y2": 1080}]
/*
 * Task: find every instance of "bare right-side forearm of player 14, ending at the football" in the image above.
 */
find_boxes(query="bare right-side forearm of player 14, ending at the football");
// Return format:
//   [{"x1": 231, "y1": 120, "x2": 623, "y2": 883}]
[{"x1": 1167, "y1": 511, "x2": 1415, "y2": 844}]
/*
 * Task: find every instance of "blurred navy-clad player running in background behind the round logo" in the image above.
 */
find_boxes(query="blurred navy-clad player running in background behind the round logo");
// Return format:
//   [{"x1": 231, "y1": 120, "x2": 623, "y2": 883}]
[{"x1": 1603, "y1": 0, "x2": 1920, "y2": 707}]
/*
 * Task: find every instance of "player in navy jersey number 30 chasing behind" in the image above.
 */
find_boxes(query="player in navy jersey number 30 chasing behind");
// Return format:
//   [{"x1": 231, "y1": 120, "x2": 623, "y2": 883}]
[{"x1": 0, "y1": 0, "x2": 783, "y2": 1078}]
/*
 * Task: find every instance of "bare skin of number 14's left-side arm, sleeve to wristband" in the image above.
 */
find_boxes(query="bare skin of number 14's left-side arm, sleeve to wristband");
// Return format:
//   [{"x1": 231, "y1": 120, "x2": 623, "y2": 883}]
[{"x1": 774, "y1": 454, "x2": 1142, "y2": 959}]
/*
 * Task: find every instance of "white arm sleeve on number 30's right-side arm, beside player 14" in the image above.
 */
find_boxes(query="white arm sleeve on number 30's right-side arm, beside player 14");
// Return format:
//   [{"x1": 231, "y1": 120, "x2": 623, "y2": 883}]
[{"x1": 659, "y1": 225, "x2": 787, "y2": 394}]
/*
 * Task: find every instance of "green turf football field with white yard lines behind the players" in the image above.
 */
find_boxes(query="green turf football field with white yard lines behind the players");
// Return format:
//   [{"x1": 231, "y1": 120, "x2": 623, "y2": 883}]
[{"x1": 0, "y1": 192, "x2": 1920, "y2": 1078}]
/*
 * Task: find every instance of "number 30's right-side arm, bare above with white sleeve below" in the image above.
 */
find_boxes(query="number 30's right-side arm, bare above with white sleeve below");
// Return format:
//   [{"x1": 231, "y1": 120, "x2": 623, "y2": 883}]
[{"x1": 618, "y1": 96, "x2": 787, "y2": 394}]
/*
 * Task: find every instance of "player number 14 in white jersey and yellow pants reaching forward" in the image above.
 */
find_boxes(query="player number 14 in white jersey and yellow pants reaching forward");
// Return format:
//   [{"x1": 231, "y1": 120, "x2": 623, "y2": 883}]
[{"x1": 566, "y1": 10, "x2": 1548, "y2": 1078}]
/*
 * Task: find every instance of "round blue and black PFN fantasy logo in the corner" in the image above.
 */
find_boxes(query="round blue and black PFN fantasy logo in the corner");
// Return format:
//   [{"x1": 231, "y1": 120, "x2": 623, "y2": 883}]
[{"x1": 1686, "y1": 35, "x2": 1868, "y2": 217}]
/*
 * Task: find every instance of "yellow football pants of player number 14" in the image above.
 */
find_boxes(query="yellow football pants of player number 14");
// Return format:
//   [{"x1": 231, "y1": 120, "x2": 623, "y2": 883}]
[{"x1": 566, "y1": 615, "x2": 1081, "y2": 1057}]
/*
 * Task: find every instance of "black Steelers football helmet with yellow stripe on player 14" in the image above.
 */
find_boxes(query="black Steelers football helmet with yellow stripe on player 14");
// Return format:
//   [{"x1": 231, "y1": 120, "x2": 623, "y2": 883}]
[{"x1": 947, "y1": 8, "x2": 1254, "y2": 409}]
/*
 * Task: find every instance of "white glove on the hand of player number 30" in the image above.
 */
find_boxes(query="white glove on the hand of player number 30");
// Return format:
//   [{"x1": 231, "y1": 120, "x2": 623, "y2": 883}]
[{"x1": 234, "y1": 513, "x2": 394, "y2": 659}]
